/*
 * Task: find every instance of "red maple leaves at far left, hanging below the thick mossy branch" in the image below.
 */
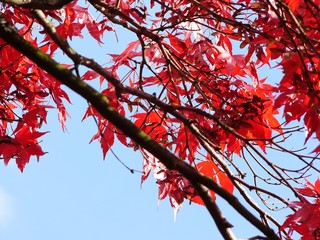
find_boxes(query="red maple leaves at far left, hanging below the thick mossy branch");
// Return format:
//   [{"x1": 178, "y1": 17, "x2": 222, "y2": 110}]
[{"x1": 0, "y1": 16, "x2": 58, "y2": 171}]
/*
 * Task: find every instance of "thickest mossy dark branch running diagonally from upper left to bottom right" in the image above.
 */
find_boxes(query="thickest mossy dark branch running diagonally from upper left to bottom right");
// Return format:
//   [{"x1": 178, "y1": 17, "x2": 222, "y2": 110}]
[{"x1": 0, "y1": 16, "x2": 280, "y2": 240}]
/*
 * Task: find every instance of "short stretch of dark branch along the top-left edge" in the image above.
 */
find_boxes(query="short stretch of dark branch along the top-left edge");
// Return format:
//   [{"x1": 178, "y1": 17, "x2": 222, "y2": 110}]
[{"x1": 0, "y1": 0, "x2": 73, "y2": 10}]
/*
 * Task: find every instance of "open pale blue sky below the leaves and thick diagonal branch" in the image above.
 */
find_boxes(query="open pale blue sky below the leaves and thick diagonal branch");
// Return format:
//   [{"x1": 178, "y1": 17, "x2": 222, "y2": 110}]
[{"x1": 0, "y1": 89, "x2": 264, "y2": 240}]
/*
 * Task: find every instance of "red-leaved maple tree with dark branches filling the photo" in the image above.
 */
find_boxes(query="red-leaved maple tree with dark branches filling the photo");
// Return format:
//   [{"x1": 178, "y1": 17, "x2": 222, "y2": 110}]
[{"x1": 0, "y1": 0, "x2": 320, "y2": 240}]
